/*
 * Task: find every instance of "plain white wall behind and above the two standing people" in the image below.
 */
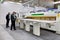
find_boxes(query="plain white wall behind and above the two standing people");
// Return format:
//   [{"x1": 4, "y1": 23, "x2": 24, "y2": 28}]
[{"x1": 0, "y1": 2, "x2": 22, "y2": 24}]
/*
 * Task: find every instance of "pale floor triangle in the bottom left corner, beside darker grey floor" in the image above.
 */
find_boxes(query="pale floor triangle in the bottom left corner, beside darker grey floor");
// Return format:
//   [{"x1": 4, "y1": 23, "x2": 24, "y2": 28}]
[{"x1": 0, "y1": 25, "x2": 15, "y2": 40}]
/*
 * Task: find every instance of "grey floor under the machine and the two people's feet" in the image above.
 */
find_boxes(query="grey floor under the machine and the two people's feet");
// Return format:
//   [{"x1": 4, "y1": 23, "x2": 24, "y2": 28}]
[{"x1": 2, "y1": 25, "x2": 60, "y2": 40}]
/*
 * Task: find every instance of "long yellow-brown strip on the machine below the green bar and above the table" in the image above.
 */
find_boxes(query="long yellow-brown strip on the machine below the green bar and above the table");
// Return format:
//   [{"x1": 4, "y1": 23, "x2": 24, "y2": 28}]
[{"x1": 26, "y1": 16, "x2": 56, "y2": 21}]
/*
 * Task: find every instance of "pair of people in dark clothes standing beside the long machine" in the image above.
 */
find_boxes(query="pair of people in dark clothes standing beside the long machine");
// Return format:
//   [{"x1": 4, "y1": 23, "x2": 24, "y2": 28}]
[{"x1": 6, "y1": 12, "x2": 17, "y2": 30}]
